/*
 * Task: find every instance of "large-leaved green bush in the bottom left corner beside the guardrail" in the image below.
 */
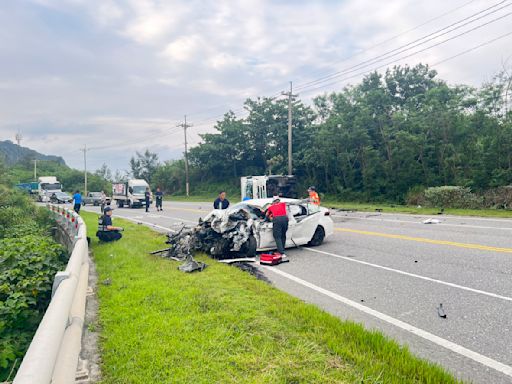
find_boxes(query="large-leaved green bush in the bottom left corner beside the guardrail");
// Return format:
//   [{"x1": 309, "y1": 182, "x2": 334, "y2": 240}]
[{"x1": 0, "y1": 235, "x2": 66, "y2": 380}]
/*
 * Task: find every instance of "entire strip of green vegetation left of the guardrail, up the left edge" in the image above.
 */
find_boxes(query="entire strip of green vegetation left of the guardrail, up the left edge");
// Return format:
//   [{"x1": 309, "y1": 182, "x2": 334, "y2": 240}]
[{"x1": 0, "y1": 168, "x2": 67, "y2": 382}]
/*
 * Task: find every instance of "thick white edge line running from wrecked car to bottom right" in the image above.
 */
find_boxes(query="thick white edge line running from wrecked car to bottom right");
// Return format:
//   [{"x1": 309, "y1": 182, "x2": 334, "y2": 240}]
[{"x1": 262, "y1": 266, "x2": 512, "y2": 377}]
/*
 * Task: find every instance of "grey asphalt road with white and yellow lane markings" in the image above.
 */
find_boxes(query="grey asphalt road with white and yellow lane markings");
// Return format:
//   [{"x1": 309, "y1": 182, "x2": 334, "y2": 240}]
[{"x1": 81, "y1": 202, "x2": 512, "y2": 383}]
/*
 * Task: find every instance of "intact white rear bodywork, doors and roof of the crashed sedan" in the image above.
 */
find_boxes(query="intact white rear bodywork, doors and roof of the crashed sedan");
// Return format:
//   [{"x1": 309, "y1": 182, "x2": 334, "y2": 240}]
[{"x1": 233, "y1": 198, "x2": 333, "y2": 251}]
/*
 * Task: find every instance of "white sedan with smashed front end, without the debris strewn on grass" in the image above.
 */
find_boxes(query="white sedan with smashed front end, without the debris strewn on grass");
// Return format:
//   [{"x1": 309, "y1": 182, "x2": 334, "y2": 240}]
[{"x1": 202, "y1": 198, "x2": 333, "y2": 257}]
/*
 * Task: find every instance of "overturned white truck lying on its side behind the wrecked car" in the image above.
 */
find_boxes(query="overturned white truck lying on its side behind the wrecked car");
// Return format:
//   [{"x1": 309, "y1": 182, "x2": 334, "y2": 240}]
[{"x1": 240, "y1": 175, "x2": 297, "y2": 200}]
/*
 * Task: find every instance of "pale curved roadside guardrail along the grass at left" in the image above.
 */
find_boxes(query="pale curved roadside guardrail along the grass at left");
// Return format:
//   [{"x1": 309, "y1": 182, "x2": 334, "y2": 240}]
[{"x1": 13, "y1": 204, "x2": 89, "y2": 384}]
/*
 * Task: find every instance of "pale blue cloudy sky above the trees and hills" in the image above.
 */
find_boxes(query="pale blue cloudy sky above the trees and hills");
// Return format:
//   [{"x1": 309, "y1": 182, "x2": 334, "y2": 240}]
[{"x1": 0, "y1": 0, "x2": 512, "y2": 170}]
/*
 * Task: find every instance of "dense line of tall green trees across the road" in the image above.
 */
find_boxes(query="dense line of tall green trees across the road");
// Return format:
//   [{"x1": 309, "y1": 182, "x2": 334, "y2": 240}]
[{"x1": 185, "y1": 64, "x2": 512, "y2": 201}]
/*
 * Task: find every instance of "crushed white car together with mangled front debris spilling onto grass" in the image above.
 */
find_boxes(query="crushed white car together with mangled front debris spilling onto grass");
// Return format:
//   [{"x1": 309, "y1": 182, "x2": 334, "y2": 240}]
[{"x1": 152, "y1": 199, "x2": 333, "y2": 271}]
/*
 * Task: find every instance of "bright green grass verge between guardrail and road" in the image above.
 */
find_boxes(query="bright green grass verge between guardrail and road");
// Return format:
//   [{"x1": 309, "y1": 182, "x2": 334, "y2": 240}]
[{"x1": 82, "y1": 212, "x2": 456, "y2": 384}]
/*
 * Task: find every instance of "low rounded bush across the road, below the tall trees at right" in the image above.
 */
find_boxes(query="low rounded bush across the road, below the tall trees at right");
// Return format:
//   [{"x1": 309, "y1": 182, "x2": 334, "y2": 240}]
[{"x1": 424, "y1": 186, "x2": 483, "y2": 209}]
